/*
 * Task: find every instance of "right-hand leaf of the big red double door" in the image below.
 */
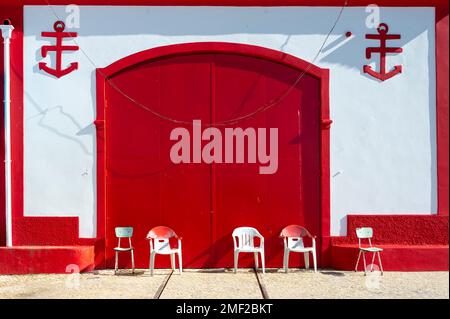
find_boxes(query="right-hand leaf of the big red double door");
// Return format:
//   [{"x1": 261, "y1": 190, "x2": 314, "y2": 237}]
[{"x1": 213, "y1": 55, "x2": 319, "y2": 267}]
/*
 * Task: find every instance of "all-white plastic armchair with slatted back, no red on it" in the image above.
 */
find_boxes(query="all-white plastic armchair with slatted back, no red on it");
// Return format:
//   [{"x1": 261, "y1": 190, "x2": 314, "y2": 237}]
[{"x1": 232, "y1": 227, "x2": 266, "y2": 273}]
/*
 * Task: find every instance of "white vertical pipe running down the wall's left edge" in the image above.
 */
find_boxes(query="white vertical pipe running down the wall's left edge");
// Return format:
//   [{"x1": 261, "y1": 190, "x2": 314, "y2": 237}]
[{"x1": 0, "y1": 20, "x2": 14, "y2": 247}]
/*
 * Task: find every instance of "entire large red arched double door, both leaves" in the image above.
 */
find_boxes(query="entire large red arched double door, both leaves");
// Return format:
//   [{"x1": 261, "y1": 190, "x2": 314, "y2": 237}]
[{"x1": 105, "y1": 48, "x2": 320, "y2": 268}]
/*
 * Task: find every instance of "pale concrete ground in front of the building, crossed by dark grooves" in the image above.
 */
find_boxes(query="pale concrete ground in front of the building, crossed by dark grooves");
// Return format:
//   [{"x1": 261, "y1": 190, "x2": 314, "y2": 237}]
[{"x1": 0, "y1": 269, "x2": 449, "y2": 299}]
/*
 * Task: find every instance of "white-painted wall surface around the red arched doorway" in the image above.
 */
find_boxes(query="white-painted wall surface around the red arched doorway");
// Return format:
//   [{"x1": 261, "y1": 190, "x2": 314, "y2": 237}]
[{"x1": 24, "y1": 6, "x2": 437, "y2": 237}]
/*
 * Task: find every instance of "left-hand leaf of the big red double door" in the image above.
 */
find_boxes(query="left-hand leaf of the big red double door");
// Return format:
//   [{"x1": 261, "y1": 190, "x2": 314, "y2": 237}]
[{"x1": 106, "y1": 56, "x2": 211, "y2": 267}]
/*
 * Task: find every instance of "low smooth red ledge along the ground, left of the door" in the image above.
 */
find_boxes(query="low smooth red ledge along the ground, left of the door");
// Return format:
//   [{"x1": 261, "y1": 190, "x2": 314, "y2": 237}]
[{"x1": 0, "y1": 246, "x2": 94, "y2": 275}]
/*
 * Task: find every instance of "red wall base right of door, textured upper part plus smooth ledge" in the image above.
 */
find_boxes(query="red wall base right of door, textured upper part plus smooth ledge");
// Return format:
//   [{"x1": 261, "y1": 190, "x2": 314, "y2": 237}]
[{"x1": 330, "y1": 215, "x2": 449, "y2": 271}]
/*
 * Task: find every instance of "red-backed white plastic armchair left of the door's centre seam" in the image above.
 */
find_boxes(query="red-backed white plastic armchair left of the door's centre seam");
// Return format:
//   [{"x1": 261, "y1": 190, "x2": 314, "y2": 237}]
[{"x1": 147, "y1": 226, "x2": 183, "y2": 276}]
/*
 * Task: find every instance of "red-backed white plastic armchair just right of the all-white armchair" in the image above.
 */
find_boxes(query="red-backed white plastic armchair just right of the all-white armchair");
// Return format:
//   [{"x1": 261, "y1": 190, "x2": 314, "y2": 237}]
[{"x1": 280, "y1": 225, "x2": 317, "y2": 273}]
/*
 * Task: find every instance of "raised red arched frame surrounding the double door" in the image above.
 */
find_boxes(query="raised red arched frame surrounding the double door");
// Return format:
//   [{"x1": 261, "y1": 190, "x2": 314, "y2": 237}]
[{"x1": 94, "y1": 42, "x2": 332, "y2": 267}]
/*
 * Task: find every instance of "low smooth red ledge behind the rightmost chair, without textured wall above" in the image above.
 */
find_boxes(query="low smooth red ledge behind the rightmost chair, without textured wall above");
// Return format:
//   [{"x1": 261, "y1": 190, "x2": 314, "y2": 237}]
[{"x1": 331, "y1": 244, "x2": 449, "y2": 271}]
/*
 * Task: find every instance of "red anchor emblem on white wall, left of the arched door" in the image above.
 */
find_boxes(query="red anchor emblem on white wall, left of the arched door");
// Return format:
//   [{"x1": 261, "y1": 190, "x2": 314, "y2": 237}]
[{"x1": 39, "y1": 21, "x2": 79, "y2": 78}]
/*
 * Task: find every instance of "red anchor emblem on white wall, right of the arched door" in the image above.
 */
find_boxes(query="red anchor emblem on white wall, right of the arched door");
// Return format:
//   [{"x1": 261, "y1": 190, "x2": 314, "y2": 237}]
[{"x1": 363, "y1": 23, "x2": 403, "y2": 81}]
